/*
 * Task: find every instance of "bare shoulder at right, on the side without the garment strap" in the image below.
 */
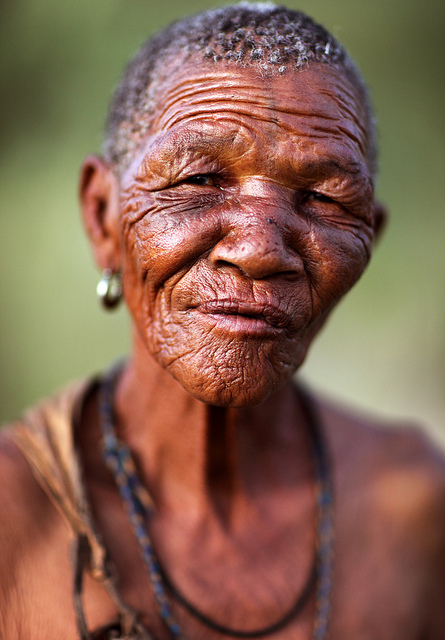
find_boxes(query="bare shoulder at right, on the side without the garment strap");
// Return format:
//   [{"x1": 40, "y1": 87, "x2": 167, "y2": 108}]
[{"x1": 317, "y1": 400, "x2": 445, "y2": 640}]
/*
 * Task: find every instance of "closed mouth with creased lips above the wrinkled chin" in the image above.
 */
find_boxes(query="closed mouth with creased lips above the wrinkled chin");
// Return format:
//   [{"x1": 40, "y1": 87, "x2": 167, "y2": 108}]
[{"x1": 195, "y1": 299, "x2": 291, "y2": 334}]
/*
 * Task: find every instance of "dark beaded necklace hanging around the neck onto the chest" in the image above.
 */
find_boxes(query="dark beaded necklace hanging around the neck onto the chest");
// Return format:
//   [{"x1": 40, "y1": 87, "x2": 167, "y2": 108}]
[{"x1": 99, "y1": 365, "x2": 333, "y2": 640}]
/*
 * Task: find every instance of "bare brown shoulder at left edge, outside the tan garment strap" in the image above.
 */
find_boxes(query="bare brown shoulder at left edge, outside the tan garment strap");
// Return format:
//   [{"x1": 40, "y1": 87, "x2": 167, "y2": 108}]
[{"x1": 0, "y1": 429, "x2": 75, "y2": 640}]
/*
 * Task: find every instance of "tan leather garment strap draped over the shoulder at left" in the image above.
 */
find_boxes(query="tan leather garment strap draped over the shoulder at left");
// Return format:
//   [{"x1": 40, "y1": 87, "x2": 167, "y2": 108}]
[{"x1": 7, "y1": 379, "x2": 155, "y2": 640}]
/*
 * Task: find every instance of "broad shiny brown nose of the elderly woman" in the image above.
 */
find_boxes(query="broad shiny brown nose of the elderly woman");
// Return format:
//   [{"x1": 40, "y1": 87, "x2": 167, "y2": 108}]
[{"x1": 209, "y1": 203, "x2": 304, "y2": 279}]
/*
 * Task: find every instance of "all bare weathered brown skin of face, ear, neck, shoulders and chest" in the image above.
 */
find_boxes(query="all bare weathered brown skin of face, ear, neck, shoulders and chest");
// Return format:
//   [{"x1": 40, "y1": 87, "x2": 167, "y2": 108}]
[{"x1": 0, "y1": 63, "x2": 445, "y2": 640}]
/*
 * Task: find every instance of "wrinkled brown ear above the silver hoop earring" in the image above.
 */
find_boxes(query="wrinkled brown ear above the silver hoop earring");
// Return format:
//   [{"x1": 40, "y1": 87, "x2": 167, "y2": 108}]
[{"x1": 79, "y1": 156, "x2": 121, "y2": 271}]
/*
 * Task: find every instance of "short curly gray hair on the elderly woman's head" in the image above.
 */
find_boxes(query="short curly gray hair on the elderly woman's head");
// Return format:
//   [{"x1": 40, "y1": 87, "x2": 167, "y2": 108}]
[{"x1": 103, "y1": 2, "x2": 377, "y2": 178}]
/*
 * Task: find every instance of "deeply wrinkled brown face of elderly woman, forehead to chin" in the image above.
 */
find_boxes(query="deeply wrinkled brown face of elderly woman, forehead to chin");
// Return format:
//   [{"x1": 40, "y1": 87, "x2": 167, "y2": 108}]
[{"x1": 113, "y1": 62, "x2": 374, "y2": 406}]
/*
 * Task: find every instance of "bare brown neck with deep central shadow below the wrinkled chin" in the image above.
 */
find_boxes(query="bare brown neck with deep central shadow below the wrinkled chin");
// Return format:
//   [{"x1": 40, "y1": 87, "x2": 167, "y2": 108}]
[{"x1": 115, "y1": 330, "x2": 311, "y2": 524}]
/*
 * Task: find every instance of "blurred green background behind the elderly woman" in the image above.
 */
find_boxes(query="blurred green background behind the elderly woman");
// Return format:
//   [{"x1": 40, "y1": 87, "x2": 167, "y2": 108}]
[{"x1": 0, "y1": 0, "x2": 445, "y2": 443}]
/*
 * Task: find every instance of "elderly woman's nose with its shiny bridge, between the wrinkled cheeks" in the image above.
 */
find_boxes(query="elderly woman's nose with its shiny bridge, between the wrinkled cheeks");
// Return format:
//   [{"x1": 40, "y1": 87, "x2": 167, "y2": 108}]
[{"x1": 210, "y1": 189, "x2": 302, "y2": 278}]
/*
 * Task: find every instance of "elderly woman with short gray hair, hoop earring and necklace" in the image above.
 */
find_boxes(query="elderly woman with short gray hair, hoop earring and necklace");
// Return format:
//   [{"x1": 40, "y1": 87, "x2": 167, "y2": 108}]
[{"x1": 0, "y1": 3, "x2": 445, "y2": 640}]
